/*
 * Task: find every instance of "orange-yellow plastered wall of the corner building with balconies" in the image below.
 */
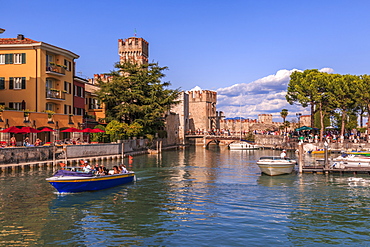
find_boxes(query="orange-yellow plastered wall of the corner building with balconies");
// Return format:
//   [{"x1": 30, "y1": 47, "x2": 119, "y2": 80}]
[{"x1": 0, "y1": 35, "x2": 80, "y2": 131}]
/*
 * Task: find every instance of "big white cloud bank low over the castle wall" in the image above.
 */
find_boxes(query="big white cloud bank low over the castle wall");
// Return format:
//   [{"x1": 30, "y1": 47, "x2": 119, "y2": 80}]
[{"x1": 216, "y1": 68, "x2": 334, "y2": 121}]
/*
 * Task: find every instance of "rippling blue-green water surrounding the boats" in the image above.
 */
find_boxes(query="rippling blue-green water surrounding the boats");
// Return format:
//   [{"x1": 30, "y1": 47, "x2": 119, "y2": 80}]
[{"x1": 0, "y1": 146, "x2": 370, "y2": 246}]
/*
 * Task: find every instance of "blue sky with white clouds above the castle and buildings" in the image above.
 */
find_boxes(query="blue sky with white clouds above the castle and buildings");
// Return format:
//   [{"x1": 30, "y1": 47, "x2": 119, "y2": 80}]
[{"x1": 0, "y1": 0, "x2": 370, "y2": 121}]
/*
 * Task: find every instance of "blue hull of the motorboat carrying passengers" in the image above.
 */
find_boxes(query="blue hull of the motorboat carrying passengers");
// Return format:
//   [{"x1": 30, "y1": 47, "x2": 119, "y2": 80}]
[{"x1": 46, "y1": 172, "x2": 135, "y2": 193}]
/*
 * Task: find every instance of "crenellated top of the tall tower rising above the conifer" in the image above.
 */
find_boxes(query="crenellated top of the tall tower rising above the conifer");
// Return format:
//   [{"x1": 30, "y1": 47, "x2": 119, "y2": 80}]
[{"x1": 118, "y1": 37, "x2": 149, "y2": 64}]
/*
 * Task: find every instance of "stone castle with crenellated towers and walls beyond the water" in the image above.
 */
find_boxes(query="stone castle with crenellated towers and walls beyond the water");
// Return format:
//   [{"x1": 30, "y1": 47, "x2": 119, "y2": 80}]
[{"x1": 89, "y1": 37, "x2": 281, "y2": 145}]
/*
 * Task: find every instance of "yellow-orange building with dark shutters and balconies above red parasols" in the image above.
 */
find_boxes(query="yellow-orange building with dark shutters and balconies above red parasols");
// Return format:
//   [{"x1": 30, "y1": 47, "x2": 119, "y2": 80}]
[{"x1": 0, "y1": 35, "x2": 82, "y2": 141}]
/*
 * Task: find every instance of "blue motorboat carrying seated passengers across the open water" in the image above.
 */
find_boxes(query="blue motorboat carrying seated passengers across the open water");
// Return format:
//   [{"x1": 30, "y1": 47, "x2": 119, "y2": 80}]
[{"x1": 46, "y1": 167, "x2": 135, "y2": 193}]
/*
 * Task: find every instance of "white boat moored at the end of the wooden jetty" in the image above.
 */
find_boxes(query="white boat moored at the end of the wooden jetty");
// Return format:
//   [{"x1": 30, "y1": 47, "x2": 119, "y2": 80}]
[{"x1": 257, "y1": 156, "x2": 297, "y2": 176}]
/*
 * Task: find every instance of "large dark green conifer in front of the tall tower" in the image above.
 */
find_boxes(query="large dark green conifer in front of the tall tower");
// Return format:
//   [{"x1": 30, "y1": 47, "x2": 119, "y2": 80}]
[{"x1": 97, "y1": 62, "x2": 179, "y2": 135}]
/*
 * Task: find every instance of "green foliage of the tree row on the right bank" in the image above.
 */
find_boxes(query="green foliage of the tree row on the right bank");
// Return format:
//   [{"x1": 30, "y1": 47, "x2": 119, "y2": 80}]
[{"x1": 286, "y1": 70, "x2": 370, "y2": 139}]
